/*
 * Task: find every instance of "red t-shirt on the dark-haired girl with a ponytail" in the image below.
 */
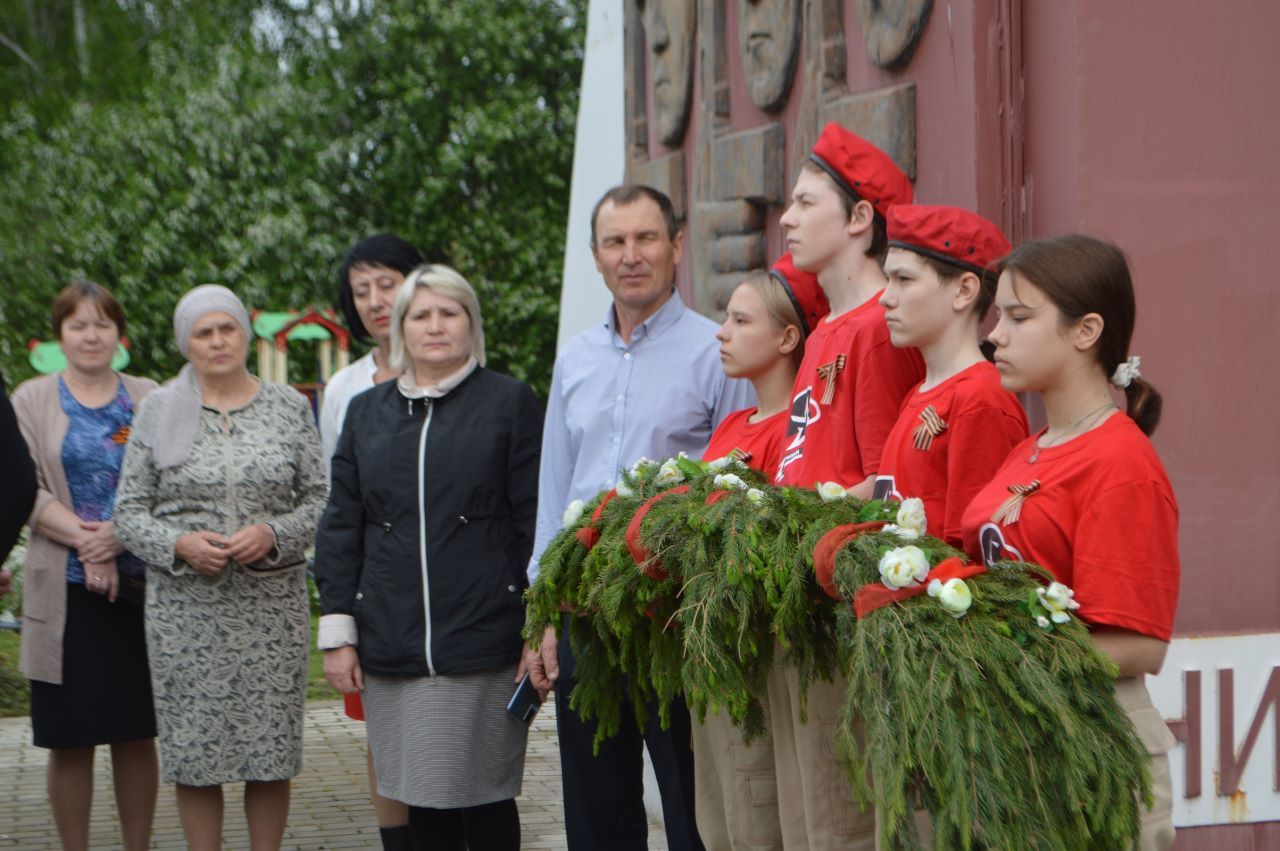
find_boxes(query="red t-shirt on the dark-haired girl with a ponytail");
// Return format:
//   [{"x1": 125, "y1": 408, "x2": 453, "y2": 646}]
[{"x1": 964, "y1": 413, "x2": 1181, "y2": 641}]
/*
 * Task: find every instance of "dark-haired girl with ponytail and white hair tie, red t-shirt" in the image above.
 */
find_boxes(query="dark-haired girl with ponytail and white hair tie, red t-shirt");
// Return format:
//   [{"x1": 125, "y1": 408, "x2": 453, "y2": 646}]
[{"x1": 963, "y1": 235, "x2": 1179, "y2": 850}]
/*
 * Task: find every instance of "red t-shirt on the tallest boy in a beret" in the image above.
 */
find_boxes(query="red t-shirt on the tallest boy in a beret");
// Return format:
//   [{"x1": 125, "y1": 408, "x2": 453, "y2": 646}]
[{"x1": 776, "y1": 293, "x2": 924, "y2": 488}]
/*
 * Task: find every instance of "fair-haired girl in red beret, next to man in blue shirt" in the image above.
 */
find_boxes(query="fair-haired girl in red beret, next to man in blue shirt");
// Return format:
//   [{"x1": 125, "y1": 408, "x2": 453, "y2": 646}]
[{"x1": 692, "y1": 255, "x2": 829, "y2": 848}]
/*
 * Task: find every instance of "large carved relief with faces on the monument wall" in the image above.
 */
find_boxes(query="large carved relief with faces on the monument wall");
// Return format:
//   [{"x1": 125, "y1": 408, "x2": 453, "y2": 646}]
[{"x1": 626, "y1": 0, "x2": 931, "y2": 321}]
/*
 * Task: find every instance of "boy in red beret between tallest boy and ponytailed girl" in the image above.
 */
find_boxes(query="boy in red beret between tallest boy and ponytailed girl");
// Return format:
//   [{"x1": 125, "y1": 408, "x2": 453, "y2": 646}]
[{"x1": 873, "y1": 205, "x2": 1027, "y2": 548}]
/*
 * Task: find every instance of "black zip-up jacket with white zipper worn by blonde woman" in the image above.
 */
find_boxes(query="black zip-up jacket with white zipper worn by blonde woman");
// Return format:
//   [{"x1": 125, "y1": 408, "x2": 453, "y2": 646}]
[{"x1": 315, "y1": 367, "x2": 543, "y2": 677}]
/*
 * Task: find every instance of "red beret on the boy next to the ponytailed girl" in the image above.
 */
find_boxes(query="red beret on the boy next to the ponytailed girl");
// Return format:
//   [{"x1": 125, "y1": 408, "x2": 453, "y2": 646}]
[{"x1": 888, "y1": 205, "x2": 1012, "y2": 275}]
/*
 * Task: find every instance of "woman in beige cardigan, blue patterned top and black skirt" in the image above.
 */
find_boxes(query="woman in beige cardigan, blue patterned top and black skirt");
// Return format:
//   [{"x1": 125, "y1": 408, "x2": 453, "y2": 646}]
[{"x1": 13, "y1": 282, "x2": 157, "y2": 851}]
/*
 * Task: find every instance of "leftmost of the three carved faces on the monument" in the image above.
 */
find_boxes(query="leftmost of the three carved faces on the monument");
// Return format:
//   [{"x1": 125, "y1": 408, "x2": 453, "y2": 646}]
[{"x1": 639, "y1": 0, "x2": 696, "y2": 146}]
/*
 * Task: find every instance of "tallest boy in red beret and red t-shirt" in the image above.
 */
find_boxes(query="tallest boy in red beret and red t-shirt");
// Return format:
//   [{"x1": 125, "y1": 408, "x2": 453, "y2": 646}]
[{"x1": 768, "y1": 124, "x2": 924, "y2": 851}]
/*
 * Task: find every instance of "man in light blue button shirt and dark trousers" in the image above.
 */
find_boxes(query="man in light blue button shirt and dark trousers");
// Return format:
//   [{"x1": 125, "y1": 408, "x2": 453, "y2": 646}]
[{"x1": 527, "y1": 186, "x2": 755, "y2": 851}]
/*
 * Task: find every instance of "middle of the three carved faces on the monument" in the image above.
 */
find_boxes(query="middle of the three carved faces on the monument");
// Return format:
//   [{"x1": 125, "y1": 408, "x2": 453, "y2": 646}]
[{"x1": 737, "y1": 0, "x2": 800, "y2": 111}]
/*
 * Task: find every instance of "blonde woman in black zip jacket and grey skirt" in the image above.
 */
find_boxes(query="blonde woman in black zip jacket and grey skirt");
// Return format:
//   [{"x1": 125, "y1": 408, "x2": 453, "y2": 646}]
[{"x1": 316, "y1": 265, "x2": 543, "y2": 851}]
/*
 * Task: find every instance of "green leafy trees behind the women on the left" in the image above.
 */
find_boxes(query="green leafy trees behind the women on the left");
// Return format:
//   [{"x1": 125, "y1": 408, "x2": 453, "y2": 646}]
[{"x1": 0, "y1": 0, "x2": 585, "y2": 389}]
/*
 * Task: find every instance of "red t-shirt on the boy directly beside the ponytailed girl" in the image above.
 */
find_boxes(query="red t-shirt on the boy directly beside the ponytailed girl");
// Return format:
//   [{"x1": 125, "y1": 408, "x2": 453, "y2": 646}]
[{"x1": 876, "y1": 361, "x2": 1027, "y2": 546}]
